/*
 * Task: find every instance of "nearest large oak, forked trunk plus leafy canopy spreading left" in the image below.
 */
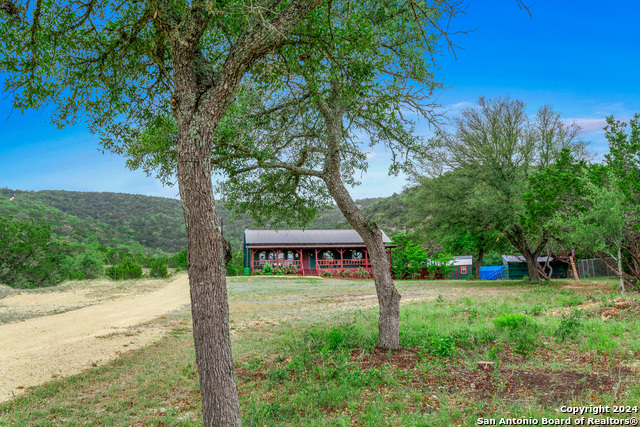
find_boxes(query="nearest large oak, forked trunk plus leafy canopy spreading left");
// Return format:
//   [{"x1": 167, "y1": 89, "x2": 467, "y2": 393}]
[{"x1": 0, "y1": 0, "x2": 320, "y2": 426}]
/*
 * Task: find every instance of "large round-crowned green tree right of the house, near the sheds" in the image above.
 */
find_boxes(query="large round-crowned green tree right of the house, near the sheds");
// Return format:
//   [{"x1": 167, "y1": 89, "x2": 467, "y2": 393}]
[{"x1": 423, "y1": 97, "x2": 586, "y2": 280}]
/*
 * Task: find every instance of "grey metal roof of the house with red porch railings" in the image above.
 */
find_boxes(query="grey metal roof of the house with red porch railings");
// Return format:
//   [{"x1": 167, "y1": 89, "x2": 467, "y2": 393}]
[{"x1": 244, "y1": 230, "x2": 391, "y2": 246}]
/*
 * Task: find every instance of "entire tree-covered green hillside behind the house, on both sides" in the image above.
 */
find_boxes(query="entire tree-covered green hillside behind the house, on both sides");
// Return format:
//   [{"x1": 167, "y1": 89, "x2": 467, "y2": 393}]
[{"x1": 0, "y1": 188, "x2": 407, "y2": 253}]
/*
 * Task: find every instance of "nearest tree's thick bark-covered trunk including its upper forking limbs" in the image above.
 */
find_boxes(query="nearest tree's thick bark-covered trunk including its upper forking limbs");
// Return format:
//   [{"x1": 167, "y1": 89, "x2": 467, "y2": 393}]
[{"x1": 165, "y1": 0, "x2": 320, "y2": 427}]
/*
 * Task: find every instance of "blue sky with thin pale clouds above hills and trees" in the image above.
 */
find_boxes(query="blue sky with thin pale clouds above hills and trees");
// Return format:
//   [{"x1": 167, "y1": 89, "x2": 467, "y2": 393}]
[{"x1": 0, "y1": 0, "x2": 640, "y2": 198}]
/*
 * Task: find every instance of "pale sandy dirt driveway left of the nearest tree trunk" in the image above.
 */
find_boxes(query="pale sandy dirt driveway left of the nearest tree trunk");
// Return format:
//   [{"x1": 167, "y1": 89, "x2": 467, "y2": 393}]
[{"x1": 0, "y1": 274, "x2": 190, "y2": 402}]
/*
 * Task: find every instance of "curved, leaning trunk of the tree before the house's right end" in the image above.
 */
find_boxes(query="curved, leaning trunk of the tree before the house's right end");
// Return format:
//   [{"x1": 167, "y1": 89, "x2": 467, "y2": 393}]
[{"x1": 321, "y1": 92, "x2": 401, "y2": 349}]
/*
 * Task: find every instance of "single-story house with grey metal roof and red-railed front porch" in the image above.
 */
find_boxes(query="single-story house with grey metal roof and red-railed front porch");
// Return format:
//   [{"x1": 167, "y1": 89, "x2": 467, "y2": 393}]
[{"x1": 243, "y1": 230, "x2": 396, "y2": 276}]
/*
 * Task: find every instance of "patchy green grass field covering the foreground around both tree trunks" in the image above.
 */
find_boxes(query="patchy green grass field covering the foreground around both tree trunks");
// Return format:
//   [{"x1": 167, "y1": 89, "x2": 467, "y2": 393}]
[{"x1": 0, "y1": 277, "x2": 640, "y2": 426}]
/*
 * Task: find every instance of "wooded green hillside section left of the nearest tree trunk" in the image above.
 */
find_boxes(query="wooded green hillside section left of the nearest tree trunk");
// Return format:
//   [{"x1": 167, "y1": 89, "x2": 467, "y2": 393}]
[{"x1": 0, "y1": 189, "x2": 187, "y2": 252}]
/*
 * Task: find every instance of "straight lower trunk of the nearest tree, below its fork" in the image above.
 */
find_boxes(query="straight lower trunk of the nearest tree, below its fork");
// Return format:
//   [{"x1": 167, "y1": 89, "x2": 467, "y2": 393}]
[{"x1": 178, "y1": 129, "x2": 241, "y2": 427}]
